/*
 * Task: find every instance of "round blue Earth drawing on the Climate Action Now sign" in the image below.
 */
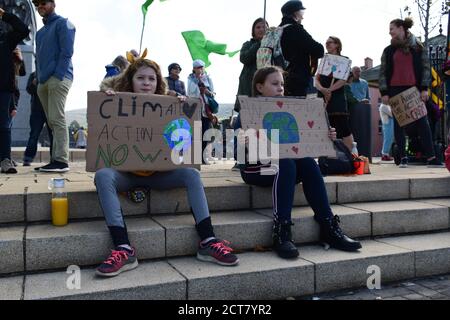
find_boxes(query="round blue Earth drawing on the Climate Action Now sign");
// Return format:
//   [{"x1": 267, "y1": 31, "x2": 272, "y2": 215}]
[{"x1": 163, "y1": 118, "x2": 192, "y2": 151}]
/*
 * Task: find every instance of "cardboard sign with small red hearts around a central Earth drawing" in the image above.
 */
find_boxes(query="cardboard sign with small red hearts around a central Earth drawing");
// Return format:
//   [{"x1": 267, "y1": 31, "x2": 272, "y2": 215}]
[{"x1": 239, "y1": 96, "x2": 336, "y2": 159}]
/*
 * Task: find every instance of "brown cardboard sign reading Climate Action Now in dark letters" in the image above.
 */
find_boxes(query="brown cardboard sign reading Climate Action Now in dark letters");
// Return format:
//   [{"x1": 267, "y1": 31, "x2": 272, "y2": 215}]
[{"x1": 86, "y1": 92, "x2": 202, "y2": 172}]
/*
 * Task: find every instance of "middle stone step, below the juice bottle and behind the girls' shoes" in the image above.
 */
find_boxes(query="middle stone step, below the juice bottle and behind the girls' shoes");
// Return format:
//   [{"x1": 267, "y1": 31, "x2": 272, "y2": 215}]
[{"x1": 0, "y1": 199, "x2": 450, "y2": 274}]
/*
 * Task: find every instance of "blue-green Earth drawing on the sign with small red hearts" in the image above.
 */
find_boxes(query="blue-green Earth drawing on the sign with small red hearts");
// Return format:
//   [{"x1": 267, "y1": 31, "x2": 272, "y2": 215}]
[{"x1": 263, "y1": 112, "x2": 300, "y2": 144}]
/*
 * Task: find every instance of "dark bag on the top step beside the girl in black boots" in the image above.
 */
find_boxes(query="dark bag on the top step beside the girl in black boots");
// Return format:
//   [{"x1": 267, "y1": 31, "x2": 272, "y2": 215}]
[{"x1": 319, "y1": 139, "x2": 354, "y2": 176}]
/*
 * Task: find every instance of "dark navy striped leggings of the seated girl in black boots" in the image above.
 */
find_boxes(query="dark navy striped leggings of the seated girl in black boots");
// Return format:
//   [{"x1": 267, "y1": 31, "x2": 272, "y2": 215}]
[{"x1": 241, "y1": 158, "x2": 333, "y2": 223}]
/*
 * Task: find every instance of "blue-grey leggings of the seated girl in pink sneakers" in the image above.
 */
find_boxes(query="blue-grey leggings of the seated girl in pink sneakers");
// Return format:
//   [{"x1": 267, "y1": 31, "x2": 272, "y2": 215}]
[{"x1": 95, "y1": 168, "x2": 209, "y2": 228}]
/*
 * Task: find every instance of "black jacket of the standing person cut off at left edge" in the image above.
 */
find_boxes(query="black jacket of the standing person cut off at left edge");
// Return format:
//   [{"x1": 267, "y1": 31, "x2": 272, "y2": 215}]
[{"x1": 0, "y1": 12, "x2": 30, "y2": 92}]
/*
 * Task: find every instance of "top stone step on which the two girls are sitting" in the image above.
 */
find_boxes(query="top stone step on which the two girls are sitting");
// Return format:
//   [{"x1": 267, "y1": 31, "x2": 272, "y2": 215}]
[{"x1": 0, "y1": 173, "x2": 450, "y2": 224}]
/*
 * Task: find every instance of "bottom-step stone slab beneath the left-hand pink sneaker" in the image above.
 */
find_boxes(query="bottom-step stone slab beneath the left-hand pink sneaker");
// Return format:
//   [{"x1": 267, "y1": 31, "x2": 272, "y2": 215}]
[{"x1": 24, "y1": 261, "x2": 186, "y2": 300}]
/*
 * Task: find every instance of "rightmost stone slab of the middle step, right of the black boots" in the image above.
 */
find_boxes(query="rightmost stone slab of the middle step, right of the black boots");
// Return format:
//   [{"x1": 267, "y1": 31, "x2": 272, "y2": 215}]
[{"x1": 347, "y1": 201, "x2": 449, "y2": 236}]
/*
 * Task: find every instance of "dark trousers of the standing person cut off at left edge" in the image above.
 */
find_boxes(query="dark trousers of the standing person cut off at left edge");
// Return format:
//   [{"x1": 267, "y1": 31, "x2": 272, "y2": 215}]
[{"x1": 0, "y1": 91, "x2": 13, "y2": 161}]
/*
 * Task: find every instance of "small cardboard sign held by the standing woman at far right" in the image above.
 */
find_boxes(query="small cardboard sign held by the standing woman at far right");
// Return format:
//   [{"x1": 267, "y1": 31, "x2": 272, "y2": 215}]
[{"x1": 389, "y1": 87, "x2": 427, "y2": 127}]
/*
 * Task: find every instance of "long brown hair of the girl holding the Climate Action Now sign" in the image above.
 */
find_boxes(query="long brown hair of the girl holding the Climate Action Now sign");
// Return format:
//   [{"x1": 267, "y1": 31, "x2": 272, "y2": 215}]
[{"x1": 113, "y1": 59, "x2": 167, "y2": 95}]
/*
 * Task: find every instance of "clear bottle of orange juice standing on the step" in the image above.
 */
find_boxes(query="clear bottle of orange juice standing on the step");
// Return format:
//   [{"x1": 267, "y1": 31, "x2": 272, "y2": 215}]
[{"x1": 48, "y1": 178, "x2": 69, "y2": 226}]
